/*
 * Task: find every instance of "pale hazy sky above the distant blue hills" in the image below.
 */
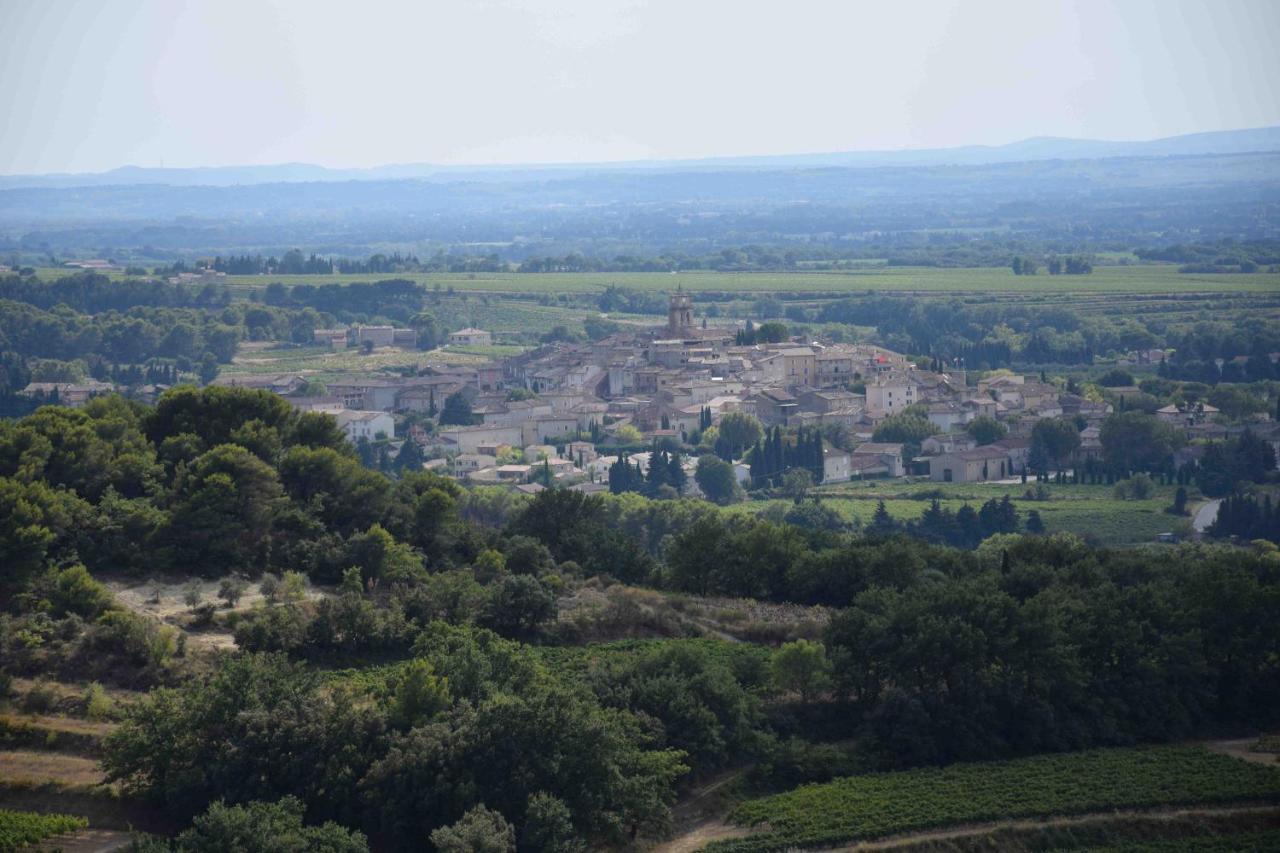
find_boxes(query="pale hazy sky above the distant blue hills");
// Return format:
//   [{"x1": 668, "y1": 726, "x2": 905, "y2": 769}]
[{"x1": 0, "y1": 0, "x2": 1280, "y2": 173}]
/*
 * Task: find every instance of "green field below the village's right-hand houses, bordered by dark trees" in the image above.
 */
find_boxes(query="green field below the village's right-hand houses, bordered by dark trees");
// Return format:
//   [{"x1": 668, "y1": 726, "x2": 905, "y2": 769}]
[{"x1": 728, "y1": 479, "x2": 1194, "y2": 546}]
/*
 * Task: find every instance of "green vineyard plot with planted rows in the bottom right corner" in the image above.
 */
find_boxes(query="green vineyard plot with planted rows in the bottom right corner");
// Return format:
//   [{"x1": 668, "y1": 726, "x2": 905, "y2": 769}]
[{"x1": 707, "y1": 745, "x2": 1280, "y2": 853}]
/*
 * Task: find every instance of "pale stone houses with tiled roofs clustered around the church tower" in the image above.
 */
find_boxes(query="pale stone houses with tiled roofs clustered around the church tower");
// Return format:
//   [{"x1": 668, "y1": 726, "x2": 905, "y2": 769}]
[{"x1": 24, "y1": 292, "x2": 1280, "y2": 492}]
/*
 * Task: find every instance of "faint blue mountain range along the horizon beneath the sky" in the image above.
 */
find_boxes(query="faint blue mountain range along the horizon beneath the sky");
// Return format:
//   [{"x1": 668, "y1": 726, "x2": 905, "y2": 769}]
[{"x1": 0, "y1": 127, "x2": 1280, "y2": 190}]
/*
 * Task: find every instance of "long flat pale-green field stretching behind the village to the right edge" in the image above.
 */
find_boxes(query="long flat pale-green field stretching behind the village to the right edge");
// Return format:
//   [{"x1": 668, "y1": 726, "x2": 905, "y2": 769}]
[{"x1": 37, "y1": 264, "x2": 1280, "y2": 293}]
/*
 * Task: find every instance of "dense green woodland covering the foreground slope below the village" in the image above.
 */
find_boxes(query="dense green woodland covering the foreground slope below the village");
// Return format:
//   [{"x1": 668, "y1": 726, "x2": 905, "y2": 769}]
[{"x1": 0, "y1": 387, "x2": 1280, "y2": 850}]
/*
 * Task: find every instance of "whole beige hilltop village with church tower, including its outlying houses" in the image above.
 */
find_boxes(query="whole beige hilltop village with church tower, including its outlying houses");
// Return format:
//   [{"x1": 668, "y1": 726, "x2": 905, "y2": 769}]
[{"x1": 17, "y1": 291, "x2": 1280, "y2": 496}]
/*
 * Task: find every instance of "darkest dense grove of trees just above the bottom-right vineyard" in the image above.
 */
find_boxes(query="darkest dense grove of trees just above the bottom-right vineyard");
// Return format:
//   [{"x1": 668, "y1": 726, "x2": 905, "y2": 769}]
[{"x1": 826, "y1": 537, "x2": 1280, "y2": 765}]
